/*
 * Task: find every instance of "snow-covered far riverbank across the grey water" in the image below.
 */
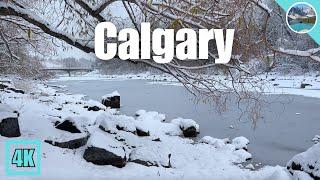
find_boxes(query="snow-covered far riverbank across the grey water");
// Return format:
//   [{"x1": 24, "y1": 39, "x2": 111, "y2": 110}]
[{"x1": 55, "y1": 71, "x2": 320, "y2": 98}]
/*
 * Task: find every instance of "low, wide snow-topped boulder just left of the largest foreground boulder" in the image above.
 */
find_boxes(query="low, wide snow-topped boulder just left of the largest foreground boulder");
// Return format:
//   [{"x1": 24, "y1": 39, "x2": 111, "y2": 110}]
[{"x1": 44, "y1": 133, "x2": 89, "y2": 149}]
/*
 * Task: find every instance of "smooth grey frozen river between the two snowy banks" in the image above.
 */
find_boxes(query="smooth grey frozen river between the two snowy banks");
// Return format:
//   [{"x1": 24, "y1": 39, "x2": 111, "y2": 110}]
[{"x1": 52, "y1": 80, "x2": 320, "y2": 166}]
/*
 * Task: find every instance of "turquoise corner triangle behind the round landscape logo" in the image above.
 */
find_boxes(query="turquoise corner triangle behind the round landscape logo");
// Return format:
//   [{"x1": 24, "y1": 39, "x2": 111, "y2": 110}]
[{"x1": 276, "y1": 0, "x2": 320, "y2": 44}]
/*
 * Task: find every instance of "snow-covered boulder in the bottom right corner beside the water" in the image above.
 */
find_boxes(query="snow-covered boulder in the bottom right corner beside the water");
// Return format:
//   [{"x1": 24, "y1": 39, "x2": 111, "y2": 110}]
[{"x1": 287, "y1": 143, "x2": 320, "y2": 179}]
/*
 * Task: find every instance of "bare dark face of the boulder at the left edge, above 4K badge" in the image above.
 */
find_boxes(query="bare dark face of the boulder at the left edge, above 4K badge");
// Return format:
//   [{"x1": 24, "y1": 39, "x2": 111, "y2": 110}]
[{"x1": 0, "y1": 117, "x2": 21, "y2": 137}]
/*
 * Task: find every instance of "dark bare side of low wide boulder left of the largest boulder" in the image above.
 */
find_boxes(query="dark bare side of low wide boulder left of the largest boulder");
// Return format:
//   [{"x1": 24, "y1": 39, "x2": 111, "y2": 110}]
[{"x1": 44, "y1": 136, "x2": 89, "y2": 149}]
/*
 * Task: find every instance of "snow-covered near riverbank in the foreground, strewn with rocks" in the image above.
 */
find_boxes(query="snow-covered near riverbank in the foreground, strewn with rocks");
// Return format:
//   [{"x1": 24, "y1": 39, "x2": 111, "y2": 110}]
[{"x1": 0, "y1": 78, "x2": 305, "y2": 179}]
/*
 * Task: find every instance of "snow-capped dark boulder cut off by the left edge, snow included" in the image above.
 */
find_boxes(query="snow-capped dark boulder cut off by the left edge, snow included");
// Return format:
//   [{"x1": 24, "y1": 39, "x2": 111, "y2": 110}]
[{"x1": 0, "y1": 104, "x2": 21, "y2": 137}]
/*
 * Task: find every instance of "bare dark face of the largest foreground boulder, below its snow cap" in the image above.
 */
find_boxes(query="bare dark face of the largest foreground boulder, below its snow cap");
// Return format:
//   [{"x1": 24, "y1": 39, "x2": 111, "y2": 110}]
[{"x1": 83, "y1": 147, "x2": 126, "y2": 168}]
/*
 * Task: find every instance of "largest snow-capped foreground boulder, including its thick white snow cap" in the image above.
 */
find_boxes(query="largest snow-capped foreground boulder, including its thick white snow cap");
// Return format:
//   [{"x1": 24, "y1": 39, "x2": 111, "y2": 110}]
[{"x1": 83, "y1": 131, "x2": 126, "y2": 168}]
